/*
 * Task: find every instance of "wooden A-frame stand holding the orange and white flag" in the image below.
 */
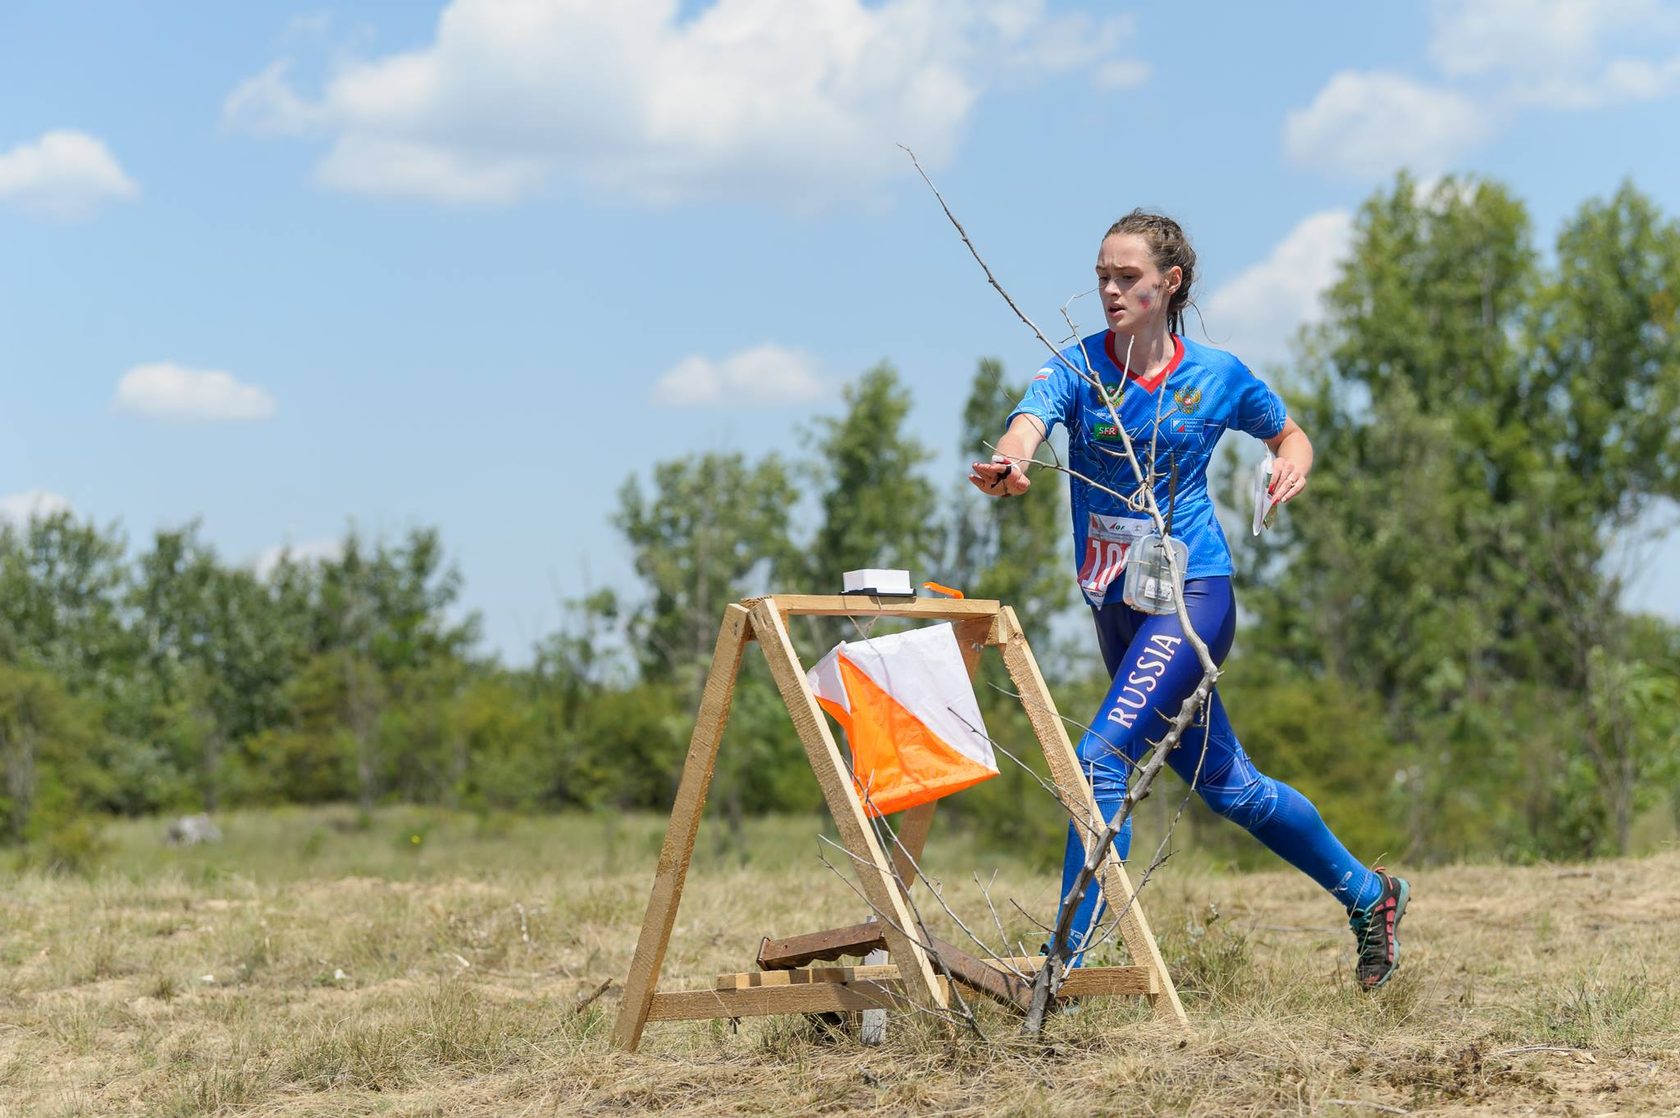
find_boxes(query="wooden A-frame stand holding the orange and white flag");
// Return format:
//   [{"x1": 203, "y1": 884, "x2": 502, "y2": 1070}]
[{"x1": 613, "y1": 595, "x2": 1184, "y2": 1051}]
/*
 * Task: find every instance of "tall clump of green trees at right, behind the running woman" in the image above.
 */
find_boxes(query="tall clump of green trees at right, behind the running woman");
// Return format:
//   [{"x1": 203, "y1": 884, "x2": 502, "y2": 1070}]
[{"x1": 1247, "y1": 177, "x2": 1680, "y2": 854}]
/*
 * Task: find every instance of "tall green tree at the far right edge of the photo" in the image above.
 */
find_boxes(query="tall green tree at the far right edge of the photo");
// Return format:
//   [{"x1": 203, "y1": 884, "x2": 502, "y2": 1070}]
[{"x1": 1517, "y1": 183, "x2": 1680, "y2": 852}]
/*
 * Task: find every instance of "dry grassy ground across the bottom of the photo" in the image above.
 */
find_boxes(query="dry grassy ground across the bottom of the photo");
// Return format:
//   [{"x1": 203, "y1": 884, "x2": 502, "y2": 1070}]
[{"x1": 0, "y1": 810, "x2": 1680, "y2": 1116}]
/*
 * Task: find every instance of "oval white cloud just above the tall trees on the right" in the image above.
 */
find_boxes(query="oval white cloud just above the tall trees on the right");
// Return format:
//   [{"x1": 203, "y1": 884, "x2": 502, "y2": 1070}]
[{"x1": 1284, "y1": 71, "x2": 1492, "y2": 178}]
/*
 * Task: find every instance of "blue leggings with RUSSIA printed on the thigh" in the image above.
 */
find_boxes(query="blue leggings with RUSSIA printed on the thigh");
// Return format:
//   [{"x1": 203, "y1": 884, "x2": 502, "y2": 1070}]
[{"x1": 1062, "y1": 577, "x2": 1383, "y2": 965}]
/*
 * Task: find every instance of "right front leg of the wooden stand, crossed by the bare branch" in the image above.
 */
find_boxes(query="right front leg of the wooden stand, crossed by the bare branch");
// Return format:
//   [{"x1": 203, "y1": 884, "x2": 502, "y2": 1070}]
[{"x1": 998, "y1": 605, "x2": 1189, "y2": 1024}]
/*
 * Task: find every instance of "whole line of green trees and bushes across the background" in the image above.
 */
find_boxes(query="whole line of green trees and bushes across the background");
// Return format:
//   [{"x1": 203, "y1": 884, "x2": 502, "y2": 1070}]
[{"x1": 0, "y1": 177, "x2": 1680, "y2": 861}]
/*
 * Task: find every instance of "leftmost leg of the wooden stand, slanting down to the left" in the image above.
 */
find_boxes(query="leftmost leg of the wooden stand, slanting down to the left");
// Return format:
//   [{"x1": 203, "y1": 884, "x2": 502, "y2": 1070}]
[{"x1": 613, "y1": 605, "x2": 753, "y2": 1052}]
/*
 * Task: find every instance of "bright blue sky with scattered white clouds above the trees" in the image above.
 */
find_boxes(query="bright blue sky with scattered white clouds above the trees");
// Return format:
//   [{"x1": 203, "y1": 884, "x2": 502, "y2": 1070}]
[{"x1": 0, "y1": 0, "x2": 1680, "y2": 659}]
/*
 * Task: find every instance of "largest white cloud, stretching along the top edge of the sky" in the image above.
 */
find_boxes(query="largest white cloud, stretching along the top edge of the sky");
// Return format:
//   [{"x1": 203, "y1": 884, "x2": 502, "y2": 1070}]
[{"x1": 223, "y1": 0, "x2": 1146, "y2": 208}]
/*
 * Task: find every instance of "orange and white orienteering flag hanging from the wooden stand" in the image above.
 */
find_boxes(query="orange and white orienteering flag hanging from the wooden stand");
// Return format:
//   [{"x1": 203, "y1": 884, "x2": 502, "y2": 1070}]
[{"x1": 805, "y1": 624, "x2": 998, "y2": 815}]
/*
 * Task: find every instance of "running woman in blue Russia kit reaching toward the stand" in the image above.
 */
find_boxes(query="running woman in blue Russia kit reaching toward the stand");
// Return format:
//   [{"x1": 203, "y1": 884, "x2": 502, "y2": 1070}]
[{"x1": 969, "y1": 210, "x2": 1411, "y2": 990}]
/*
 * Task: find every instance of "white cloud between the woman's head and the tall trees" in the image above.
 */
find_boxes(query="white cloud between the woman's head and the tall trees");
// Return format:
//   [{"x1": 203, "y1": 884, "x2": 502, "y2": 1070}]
[{"x1": 1203, "y1": 210, "x2": 1352, "y2": 365}]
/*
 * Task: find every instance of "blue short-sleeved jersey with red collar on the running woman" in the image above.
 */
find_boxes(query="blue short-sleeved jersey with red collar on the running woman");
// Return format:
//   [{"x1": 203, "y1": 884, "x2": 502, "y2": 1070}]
[{"x1": 1005, "y1": 331, "x2": 1287, "y2": 605}]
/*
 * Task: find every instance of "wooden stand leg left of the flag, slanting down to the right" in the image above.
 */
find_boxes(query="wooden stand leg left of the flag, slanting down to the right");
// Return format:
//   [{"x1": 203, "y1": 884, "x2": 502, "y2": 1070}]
[{"x1": 753, "y1": 599, "x2": 946, "y2": 1009}]
